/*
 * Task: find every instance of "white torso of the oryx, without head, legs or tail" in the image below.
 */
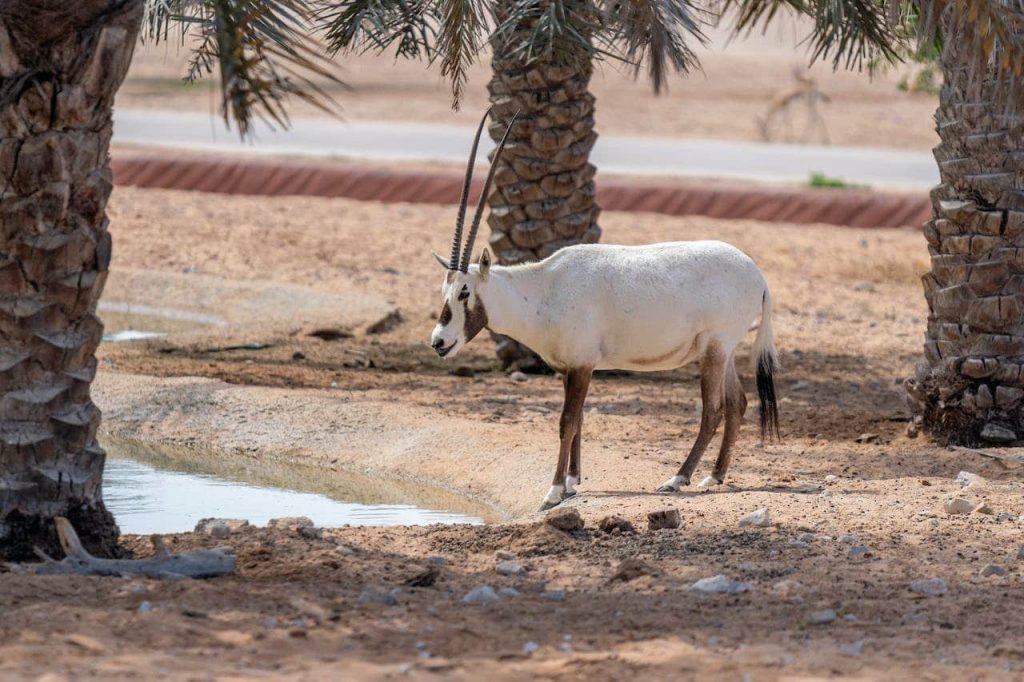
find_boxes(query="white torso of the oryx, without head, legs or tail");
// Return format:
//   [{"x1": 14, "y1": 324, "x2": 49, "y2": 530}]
[{"x1": 479, "y1": 241, "x2": 767, "y2": 372}]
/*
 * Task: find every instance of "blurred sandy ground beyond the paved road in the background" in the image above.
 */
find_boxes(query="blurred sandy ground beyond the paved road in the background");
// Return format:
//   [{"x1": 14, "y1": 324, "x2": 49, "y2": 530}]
[{"x1": 117, "y1": 21, "x2": 938, "y2": 150}]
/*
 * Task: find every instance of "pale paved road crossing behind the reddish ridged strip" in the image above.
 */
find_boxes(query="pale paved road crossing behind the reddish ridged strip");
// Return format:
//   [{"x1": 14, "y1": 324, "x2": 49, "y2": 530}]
[{"x1": 114, "y1": 110, "x2": 938, "y2": 189}]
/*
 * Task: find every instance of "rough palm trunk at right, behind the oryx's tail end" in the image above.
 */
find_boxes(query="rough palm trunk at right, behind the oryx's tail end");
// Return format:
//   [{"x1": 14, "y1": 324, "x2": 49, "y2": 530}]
[{"x1": 907, "y1": 32, "x2": 1024, "y2": 443}]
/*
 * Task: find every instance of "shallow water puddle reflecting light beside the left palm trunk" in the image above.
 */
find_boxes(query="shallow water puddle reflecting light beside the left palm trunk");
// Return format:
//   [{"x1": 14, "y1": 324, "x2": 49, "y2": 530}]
[{"x1": 103, "y1": 441, "x2": 483, "y2": 535}]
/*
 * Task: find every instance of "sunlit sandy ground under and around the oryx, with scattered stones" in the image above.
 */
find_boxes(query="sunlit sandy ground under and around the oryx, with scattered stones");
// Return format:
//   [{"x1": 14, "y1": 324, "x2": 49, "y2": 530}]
[{"x1": 0, "y1": 188, "x2": 1024, "y2": 680}]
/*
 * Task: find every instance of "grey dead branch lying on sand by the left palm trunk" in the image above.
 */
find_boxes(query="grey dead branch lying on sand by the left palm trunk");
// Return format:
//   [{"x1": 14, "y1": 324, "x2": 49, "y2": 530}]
[{"x1": 11, "y1": 516, "x2": 234, "y2": 581}]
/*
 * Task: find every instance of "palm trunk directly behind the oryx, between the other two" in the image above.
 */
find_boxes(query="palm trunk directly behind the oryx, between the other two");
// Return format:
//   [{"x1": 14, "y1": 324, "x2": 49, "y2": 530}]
[{"x1": 487, "y1": 0, "x2": 601, "y2": 370}]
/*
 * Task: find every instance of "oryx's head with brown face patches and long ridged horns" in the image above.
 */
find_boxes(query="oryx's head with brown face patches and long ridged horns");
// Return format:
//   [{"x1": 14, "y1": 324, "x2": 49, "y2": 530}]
[{"x1": 430, "y1": 109, "x2": 518, "y2": 357}]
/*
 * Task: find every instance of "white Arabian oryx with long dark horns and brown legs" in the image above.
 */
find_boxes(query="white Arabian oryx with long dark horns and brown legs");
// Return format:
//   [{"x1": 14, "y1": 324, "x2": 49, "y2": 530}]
[{"x1": 431, "y1": 107, "x2": 778, "y2": 511}]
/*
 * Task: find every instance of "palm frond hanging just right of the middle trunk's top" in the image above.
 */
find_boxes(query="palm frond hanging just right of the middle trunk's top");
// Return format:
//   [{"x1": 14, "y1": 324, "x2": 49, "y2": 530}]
[{"x1": 602, "y1": 0, "x2": 712, "y2": 93}]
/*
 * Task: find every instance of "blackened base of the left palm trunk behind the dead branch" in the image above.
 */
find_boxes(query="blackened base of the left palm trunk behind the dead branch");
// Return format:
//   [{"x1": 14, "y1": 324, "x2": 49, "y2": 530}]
[{"x1": 0, "y1": 502, "x2": 122, "y2": 561}]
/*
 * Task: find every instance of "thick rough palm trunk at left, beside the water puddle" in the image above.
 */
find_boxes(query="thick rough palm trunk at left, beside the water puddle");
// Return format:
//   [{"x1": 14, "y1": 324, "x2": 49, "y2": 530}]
[{"x1": 0, "y1": 0, "x2": 141, "y2": 559}]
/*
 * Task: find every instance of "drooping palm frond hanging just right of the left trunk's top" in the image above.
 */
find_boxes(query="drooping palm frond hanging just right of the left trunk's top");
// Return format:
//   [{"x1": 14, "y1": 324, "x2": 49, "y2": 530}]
[{"x1": 143, "y1": 0, "x2": 339, "y2": 137}]
